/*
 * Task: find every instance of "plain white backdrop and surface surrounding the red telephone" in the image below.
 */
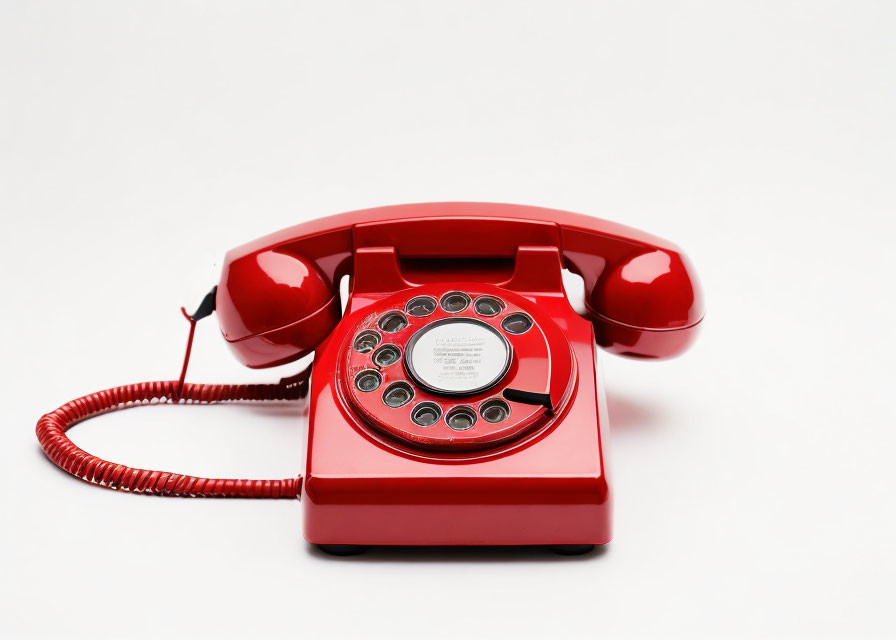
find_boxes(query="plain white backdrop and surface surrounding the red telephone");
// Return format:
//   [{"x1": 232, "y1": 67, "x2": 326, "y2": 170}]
[{"x1": 0, "y1": 0, "x2": 896, "y2": 638}]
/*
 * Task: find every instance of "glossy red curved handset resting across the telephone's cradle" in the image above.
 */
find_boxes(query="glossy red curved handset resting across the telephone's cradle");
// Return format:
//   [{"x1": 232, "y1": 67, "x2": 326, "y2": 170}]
[{"x1": 218, "y1": 202, "x2": 703, "y2": 367}]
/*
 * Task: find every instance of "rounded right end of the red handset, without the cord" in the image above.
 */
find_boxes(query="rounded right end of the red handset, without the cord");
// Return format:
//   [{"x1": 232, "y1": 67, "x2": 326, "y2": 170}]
[{"x1": 585, "y1": 247, "x2": 704, "y2": 359}]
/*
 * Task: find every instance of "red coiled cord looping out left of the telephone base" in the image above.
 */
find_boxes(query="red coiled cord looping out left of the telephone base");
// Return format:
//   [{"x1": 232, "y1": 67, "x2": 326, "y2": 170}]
[{"x1": 37, "y1": 312, "x2": 311, "y2": 498}]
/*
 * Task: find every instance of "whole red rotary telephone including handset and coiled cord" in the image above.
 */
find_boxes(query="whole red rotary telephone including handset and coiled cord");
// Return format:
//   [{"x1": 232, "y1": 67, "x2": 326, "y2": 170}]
[{"x1": 37, "y1": 203, "x2": 703, "y2": 553}]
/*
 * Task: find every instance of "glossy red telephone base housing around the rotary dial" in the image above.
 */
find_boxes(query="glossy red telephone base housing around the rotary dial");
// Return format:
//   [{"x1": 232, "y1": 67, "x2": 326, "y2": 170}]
[{"x1": 302, "y1": 247, "x2": 611, "y2": 545}]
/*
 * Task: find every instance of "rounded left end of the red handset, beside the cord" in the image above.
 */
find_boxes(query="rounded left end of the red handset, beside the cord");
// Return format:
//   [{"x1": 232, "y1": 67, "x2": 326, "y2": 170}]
[{"x1": 216, "y1": 248, "x2": 341, "y2": 368}]
